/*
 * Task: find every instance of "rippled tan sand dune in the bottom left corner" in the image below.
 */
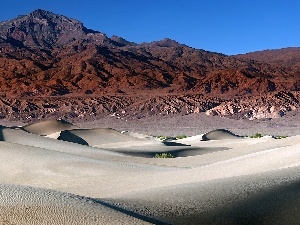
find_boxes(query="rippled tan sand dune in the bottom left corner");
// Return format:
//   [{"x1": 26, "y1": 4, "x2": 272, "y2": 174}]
[{"x1": 0, "y1": 185, "x2": 151, "y2": 225}]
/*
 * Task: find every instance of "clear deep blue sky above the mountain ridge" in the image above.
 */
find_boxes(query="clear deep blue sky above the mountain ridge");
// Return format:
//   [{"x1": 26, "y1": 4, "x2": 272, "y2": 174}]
[{"x1": 0, "y1": 0, "x2": 300, "y2": 55}]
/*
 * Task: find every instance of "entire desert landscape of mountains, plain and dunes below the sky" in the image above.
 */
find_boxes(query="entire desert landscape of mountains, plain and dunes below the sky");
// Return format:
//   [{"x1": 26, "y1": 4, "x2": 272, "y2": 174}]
[{"x1": 0, "y1": 9, "x2": 300, "y2": 225}]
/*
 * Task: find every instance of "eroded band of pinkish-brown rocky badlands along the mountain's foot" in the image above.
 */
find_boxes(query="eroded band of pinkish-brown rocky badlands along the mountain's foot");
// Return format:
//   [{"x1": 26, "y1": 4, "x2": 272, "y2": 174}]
[{"x1": 0, "y1": 92, "x2": 300, "y2": 122}]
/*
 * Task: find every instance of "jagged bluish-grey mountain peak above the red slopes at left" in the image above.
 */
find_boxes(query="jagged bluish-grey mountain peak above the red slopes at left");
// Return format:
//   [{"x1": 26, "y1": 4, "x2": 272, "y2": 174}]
[{"x1": 0, "y1": 9, "x2": 107, "y2": 48}]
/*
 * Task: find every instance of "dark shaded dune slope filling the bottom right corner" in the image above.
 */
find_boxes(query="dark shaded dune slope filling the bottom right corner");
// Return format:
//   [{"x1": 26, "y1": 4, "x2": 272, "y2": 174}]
[{"x1": 105, "y1": 167, "x2": 300, "y2": 225}]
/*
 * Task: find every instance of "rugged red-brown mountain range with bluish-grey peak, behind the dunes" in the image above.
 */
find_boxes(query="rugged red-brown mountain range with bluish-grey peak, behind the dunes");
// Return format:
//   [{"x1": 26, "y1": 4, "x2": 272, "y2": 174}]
[{"x1": 0, "y1": 9, "x2": 300, "y2": 119}]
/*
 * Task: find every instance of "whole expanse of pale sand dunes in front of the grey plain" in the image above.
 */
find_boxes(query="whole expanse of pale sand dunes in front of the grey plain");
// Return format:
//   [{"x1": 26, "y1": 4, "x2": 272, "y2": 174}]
[{"x1": 0, "y1": 118, "x2": 300, "y2": 224}]
